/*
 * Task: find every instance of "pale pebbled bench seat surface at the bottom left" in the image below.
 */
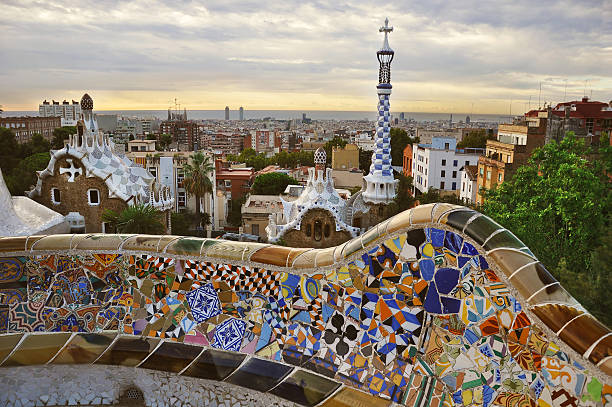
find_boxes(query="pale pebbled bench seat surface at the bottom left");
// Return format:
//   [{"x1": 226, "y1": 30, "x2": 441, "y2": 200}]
[{"x1": 0, "y1": 365, "x2": 295, "y2": 407}]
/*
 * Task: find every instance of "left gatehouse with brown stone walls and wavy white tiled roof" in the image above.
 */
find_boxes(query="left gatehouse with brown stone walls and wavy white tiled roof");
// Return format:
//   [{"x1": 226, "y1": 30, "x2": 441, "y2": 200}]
[{"x1": 28, "y1": 94, "x2": 174, "y2": 233}]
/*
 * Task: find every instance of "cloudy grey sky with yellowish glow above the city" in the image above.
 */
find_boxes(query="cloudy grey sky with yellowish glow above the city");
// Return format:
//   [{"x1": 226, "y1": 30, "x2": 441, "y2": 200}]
[{"x1": 0, "y1": 0, "x2": 612, "y2": 114}]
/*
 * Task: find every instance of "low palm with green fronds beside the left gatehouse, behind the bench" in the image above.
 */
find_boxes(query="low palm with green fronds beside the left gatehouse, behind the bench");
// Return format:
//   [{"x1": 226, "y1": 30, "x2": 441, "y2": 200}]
[{"x1": 102, "y1": 204, "x2": 166, "y2": 235}]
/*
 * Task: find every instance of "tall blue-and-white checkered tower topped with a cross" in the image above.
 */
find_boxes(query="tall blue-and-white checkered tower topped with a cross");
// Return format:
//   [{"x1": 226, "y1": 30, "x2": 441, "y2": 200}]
[{"x1": 362, "y1": 19, "x2": 397, "y2": 204}]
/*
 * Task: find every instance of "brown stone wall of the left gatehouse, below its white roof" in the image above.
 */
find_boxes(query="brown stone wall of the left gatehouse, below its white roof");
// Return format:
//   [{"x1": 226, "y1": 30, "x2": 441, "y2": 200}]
[{"x1": 36, "y1": 158, "x2": 127, "y2": 233}]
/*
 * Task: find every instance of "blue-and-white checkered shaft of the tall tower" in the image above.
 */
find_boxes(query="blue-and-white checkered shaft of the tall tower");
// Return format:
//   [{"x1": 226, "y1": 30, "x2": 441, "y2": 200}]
[{"x1": 370, "y1": 92, "x2": 393, "y2": 177}]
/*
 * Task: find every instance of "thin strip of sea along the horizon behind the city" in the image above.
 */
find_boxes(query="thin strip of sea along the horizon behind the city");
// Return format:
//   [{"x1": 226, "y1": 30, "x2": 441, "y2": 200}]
[{"x1": 2, "y1": 110, "x2": 513, "y2": 123}]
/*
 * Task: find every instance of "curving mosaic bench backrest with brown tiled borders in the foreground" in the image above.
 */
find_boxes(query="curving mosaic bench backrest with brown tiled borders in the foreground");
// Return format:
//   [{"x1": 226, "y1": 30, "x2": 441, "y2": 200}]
[{"x1": 0, "y1": 204, "x2": 612, "y2": 407}]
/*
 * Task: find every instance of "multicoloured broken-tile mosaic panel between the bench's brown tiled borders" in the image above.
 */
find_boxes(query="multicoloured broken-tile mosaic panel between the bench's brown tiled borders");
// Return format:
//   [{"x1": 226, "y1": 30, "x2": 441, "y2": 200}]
[{"x1": 0, "y1": 222, "x2": 612, "y2": 407}]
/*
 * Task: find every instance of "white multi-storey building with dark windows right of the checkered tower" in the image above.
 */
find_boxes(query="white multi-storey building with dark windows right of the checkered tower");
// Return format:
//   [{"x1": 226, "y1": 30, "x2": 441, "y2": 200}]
[{"x1": 412, "y1": 137, "x2": 484, "y2": 193}]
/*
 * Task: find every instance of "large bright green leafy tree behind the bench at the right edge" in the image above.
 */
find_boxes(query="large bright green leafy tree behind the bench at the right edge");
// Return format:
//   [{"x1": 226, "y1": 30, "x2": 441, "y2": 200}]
[{"x1": 482, "y1": 135, "x2": 612, "y2": 325}]
